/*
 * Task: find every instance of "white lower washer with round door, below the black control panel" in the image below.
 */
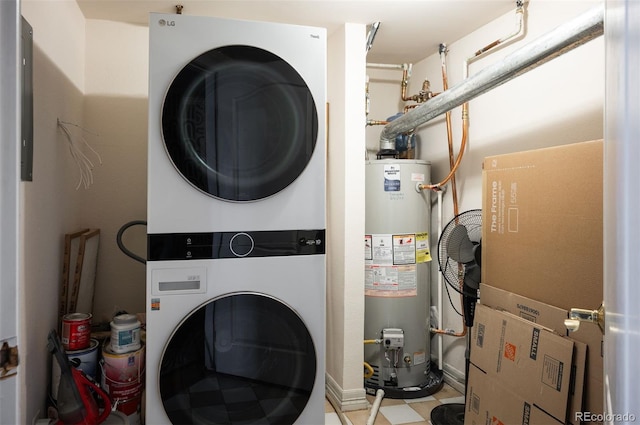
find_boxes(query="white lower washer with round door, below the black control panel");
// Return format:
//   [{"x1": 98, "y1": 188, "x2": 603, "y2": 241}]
[{"x1": 146, "y1": 255, "x2": 325, "y2": 425}]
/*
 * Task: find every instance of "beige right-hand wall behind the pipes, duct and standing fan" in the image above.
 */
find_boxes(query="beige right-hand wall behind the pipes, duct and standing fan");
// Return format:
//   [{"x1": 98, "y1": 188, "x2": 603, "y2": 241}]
[{"x1": 367, "y1": 0, "x2": 604, "y2": 378}]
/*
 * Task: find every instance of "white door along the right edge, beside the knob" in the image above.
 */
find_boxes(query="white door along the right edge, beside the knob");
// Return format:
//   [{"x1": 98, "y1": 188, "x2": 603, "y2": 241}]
[{"x1": 604, "y1": 0, "x2": 640, "y2": 423}]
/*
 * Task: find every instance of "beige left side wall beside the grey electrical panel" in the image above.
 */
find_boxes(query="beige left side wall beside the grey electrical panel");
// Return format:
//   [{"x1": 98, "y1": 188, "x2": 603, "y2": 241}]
[{"x1": 19, "y1": 0, "x2": 85, "y2": 423}]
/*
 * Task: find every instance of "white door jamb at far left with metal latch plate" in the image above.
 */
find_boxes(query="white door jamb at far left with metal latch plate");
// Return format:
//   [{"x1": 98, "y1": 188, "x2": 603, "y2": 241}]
[{"x1": 0, "y1": 0, "x2": 24, "y2": 424}]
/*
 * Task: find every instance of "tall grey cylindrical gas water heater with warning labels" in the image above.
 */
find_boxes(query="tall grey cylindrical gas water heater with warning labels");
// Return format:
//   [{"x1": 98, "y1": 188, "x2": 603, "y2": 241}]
[{"x1": 364, "y1": 159, "x2": 441, "y2": 398}]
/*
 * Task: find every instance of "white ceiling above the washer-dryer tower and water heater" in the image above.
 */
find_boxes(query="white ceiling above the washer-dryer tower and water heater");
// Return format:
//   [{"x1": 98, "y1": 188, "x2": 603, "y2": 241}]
[{"x1": 75, "y1": 0, "x2": 515, "y2": 64}]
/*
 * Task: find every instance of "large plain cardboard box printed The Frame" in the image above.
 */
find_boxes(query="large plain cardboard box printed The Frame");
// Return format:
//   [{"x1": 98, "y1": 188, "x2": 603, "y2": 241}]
[{"x1": 482, "y1": 140, "x2": 603, "y2": 310}]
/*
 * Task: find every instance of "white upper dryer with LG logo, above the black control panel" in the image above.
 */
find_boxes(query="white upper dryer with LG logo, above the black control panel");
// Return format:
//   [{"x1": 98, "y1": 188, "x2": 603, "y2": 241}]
[{"x1": 147, "y1": 14, "x2": 326, "y2": 233}]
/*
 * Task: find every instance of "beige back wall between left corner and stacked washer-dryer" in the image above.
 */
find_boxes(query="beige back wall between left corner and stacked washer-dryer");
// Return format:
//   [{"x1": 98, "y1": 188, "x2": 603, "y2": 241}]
[{"x1": 81, "y1": 19, "x2": 149, "y2": 323}]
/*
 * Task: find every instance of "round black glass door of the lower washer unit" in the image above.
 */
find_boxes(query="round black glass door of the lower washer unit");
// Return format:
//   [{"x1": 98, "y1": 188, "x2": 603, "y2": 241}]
[{"x1": 160, "y1": 293, "x2": 316, "y2": 424}]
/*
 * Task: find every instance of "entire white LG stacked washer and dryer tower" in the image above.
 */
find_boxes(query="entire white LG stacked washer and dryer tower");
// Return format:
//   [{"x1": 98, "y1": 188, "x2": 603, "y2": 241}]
[{"x1": 146, "y1": 14, "x2": 326, "y2": 425}]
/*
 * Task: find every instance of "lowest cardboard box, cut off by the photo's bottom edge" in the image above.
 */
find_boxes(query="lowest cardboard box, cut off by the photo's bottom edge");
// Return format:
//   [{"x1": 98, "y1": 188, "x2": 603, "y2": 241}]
[{"x1": 464, "y1": 365, "x2": 562, "y2": 425}]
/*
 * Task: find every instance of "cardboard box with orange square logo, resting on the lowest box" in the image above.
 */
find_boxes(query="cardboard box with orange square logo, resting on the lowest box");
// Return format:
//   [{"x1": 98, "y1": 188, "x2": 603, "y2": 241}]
[{"x1": 469, "y1": 304, "x2": 574, "y2": 422}]
